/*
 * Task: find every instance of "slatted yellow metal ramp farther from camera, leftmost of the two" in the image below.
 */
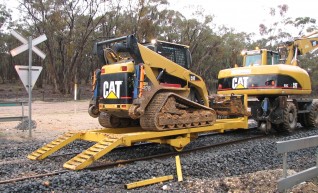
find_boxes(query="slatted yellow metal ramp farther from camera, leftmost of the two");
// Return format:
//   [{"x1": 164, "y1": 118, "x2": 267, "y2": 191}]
[{"x1": 28, "y1": 132, "x2": 81, "y2": 160}]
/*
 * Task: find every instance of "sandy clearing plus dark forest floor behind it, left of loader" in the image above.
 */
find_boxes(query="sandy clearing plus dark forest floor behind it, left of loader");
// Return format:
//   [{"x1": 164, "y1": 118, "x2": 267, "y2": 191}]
[{"x1": 0, "y1": 80, "x2": 101, "y2": 141}]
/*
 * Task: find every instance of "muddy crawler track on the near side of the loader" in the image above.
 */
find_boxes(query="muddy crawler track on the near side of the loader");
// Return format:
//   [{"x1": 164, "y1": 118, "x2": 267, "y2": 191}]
[{"x1": 140, "y1": 92, "x2": 216, "y2": 131}]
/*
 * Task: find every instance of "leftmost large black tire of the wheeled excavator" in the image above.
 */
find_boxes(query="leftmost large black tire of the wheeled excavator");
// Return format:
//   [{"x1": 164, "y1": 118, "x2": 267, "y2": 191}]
[{"x1": 282, "y1": 102, "x2": 297, "y2": 133}]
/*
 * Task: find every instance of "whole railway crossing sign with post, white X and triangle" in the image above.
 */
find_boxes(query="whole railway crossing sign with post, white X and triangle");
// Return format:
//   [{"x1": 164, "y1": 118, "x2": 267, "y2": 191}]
[{"x1": 10, "y1": 30, "x2": 47, "y2": 137}]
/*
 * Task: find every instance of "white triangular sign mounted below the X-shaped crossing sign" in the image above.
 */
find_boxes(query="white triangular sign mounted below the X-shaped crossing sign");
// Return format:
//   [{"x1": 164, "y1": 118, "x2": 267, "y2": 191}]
[{"x1": 14, "y1": 65, "x2": 43, "y2": 92}]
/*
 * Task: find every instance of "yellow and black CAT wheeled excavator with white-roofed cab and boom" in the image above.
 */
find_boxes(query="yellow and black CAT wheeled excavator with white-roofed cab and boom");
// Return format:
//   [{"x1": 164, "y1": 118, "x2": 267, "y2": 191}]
[{"x1": 217, "y1": 31, "x2": 318, "y2": 132}]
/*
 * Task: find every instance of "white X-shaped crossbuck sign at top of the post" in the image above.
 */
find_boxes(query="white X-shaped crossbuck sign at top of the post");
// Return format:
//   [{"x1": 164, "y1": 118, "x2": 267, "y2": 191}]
[{"x1": 10, "y1": 30, "x2": 47, "y2": 59}]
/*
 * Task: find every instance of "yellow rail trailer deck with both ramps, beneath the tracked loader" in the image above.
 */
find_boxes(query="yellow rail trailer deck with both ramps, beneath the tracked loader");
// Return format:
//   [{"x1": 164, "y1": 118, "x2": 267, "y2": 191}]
[{"x1": 28, "y1": 117, "x2": 248, "y2": 170}]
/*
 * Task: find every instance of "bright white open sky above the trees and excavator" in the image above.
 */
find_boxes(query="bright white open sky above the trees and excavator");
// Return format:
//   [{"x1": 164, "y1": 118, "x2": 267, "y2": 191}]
[{"x1": 169, "y1": 0, "x2": 318, "y2": 36}]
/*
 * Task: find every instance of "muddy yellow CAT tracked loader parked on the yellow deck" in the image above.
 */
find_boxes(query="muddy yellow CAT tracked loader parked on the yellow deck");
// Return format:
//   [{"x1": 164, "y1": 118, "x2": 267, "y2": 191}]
[{"x1": 88, "y1": 35, "x2": 215, "y2": 130}]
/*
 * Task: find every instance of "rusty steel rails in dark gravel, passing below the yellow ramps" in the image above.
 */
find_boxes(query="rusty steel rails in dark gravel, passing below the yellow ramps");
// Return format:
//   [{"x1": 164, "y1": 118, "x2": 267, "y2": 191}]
[{"x1": 0, "y1": 135, "x2": 268, "y2": 185}]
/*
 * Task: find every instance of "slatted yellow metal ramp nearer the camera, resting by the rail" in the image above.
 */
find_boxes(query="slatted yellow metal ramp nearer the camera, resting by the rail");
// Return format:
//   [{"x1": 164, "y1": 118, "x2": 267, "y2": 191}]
[{"x1": 63, "y1": 137, "x2": 122, "y2": 170}]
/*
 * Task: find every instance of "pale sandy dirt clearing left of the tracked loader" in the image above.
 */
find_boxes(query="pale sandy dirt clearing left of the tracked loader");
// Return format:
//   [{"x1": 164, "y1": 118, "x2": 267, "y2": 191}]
[{"x1": 0, "y1": 100, "x2": 101, "y2": 140}]
